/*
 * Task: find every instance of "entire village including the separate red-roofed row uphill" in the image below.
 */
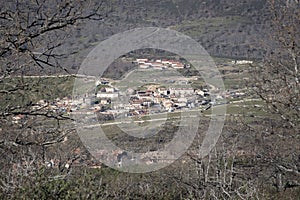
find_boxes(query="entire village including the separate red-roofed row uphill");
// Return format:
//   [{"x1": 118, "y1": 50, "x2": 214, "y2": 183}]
[{"x1": 12, "y1": 58, "x2": 250, "y2": 123}]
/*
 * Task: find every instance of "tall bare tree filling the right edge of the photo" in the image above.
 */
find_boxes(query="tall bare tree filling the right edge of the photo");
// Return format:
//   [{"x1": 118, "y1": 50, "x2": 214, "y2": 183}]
[{"x1": 251, "y1": 0, "x2": 300, "y2": 194}]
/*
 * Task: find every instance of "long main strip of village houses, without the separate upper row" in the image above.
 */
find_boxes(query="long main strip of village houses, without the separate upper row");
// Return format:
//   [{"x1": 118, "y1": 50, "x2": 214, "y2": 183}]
[{"x1": 12, "y1": 82, "x2": 245, "y2": 124}]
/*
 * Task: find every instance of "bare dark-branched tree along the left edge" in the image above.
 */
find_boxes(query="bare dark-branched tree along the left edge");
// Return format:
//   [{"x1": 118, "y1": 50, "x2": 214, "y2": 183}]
[{"x1": 0, "y1": 0, "x2": 105, "y2": 193}]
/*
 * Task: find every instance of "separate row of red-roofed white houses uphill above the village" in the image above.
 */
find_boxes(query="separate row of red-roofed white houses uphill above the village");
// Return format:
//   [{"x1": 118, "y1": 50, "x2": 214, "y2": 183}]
[{"x1": 135, "y1": 58, "x2": 189, "y2": 70}]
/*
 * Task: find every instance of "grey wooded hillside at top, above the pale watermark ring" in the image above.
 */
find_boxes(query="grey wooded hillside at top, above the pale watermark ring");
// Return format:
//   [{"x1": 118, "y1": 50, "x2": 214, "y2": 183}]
[{"x1": 67, "y1": 0, "x2": 270, "y2": 72}]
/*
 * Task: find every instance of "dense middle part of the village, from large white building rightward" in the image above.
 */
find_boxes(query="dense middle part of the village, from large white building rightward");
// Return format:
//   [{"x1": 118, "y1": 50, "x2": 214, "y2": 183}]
[{"x1": 95, "y1": 79, "x2": 209, "y2": 116}]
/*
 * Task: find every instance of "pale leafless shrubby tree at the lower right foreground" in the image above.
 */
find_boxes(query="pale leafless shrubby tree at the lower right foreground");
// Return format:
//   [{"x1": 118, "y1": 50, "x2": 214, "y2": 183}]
[{"x1": 170, "y1": 118, "x2": 261, "y2": 199}]
